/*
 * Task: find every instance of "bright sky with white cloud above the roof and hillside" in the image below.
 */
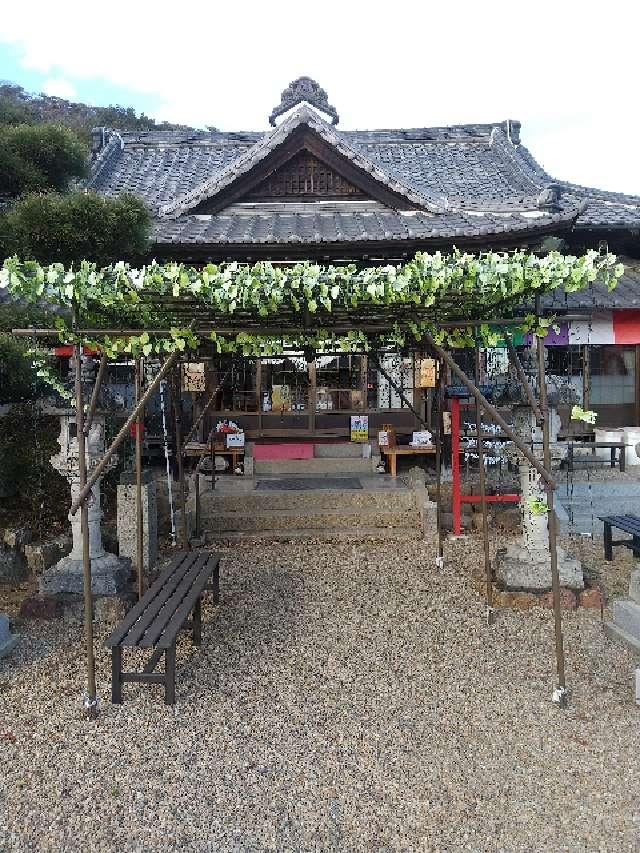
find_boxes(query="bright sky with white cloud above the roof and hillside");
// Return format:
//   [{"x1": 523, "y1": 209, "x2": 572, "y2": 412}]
[{"x1": 0, "y1": 0, "x2": 640, "y2": 195}]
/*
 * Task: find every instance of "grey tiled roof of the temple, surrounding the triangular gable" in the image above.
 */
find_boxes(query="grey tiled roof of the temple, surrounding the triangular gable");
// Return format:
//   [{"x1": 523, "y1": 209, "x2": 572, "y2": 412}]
[{"x1": 89, "y1": 105, "x2": 640, "y2": 245}]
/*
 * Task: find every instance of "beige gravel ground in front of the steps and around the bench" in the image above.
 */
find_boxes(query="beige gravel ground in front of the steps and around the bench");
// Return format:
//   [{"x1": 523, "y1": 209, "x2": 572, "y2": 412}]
[{"x1": 0, "y1": 540, "x2": 640, "y2": 853}]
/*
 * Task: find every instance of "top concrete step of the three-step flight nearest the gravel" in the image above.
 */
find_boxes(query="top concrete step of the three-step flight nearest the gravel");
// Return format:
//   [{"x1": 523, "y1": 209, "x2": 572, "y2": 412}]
[{"x1": 200, "y1": 489, "x2": 424, "y2": 516}]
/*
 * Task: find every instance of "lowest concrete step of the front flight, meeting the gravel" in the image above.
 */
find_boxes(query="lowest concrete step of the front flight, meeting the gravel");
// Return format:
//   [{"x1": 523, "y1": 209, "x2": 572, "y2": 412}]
[{"x1": 204, "y1": 527, "x2": 423, "y2": 545}]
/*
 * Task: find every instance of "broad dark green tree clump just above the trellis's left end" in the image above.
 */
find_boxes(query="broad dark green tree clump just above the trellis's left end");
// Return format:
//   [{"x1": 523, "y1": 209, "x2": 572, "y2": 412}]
[{"x1": 0, "y1": 192, "x2": 150, "y2": 266}]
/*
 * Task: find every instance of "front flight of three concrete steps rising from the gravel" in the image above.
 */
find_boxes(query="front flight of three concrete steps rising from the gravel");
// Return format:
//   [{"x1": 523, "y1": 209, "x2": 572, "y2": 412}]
[{"x1": 195, "y1": 482, "x2": 427, "y2": 543}]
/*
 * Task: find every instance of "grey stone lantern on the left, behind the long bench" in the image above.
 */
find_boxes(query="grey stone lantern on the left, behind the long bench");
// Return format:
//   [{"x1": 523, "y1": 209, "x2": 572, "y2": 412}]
[{"x1": 40, "y1": 358, "x2": 131, "y2": 595}]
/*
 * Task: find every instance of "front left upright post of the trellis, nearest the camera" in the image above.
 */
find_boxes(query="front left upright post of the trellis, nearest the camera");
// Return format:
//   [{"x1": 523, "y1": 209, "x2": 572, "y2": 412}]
[{"x1": 75, "y1": 344, "x2": 98, "y2": 720}]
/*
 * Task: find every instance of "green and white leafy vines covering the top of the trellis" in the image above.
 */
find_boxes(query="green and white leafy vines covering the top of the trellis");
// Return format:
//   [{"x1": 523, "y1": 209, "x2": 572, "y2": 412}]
[{"x1": 0, "y1": 250, "x2": 624, "y2": 355}]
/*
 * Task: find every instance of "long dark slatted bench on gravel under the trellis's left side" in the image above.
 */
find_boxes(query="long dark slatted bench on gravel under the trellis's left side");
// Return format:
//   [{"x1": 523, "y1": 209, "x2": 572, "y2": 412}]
[{"x1": 106, "y1": 551, "x2": 220, "y2": 705}]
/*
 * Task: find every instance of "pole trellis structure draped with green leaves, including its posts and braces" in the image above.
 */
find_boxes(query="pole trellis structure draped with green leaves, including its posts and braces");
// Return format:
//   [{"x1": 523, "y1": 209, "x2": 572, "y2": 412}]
[{"x1": 5, "y1": 252, "x2": 623, "y2": 716}]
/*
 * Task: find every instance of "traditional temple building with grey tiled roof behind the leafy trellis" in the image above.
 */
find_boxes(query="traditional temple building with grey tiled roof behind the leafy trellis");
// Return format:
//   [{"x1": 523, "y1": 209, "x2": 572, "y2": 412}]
[{"x1": 88, "y1": 77, "x2": 640, "y2": 438}]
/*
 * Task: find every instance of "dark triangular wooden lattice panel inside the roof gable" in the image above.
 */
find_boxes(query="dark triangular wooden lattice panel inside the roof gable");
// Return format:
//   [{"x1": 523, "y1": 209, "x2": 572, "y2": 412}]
[{"x1": 245, "y1": 150, "x2": 369, "y2": 201}]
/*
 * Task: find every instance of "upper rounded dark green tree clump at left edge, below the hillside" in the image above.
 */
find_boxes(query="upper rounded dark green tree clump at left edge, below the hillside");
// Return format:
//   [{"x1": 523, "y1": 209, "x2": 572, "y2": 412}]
[{"x1": 0, "y1": 124, "x2": 88, "y2": 196}]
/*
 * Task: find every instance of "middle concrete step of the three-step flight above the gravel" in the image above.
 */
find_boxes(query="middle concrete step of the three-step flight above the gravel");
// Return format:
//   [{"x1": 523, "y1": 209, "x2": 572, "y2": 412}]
[{"x1": 201, "y1": 507, "x2": 422, "y2": 532}]
